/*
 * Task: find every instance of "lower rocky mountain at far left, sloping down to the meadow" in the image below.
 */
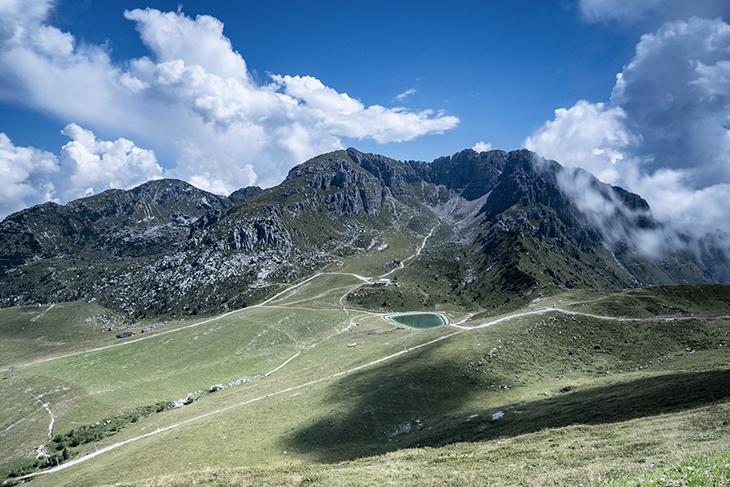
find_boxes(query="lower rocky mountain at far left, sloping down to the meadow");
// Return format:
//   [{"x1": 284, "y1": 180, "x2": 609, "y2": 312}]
[{"x1": 0, "y1": 180, "x2": 258, "y2": 314}]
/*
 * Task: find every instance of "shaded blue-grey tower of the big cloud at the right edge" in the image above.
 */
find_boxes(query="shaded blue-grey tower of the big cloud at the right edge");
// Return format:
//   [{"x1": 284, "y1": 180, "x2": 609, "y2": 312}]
[{"x1": 611, "y1": 18, "x2": 730, "y2": 187}]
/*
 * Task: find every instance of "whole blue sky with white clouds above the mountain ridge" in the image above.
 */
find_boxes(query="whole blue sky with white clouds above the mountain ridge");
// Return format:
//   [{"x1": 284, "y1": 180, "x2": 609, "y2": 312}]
[{"x1": 0, "y1": 0, "x2": 730, "y2": 230}]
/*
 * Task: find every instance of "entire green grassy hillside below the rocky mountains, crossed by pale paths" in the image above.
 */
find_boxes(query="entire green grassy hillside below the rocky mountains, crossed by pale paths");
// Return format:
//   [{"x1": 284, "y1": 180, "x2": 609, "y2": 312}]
[{"x1": 0, "y1": 242, "x2": 730, "y2": 486}]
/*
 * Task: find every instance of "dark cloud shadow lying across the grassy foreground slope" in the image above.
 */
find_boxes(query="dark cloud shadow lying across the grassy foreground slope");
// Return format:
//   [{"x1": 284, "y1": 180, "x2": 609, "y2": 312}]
[{"x1": 282, "y1": 346, "x2": 730, "y2": 463}]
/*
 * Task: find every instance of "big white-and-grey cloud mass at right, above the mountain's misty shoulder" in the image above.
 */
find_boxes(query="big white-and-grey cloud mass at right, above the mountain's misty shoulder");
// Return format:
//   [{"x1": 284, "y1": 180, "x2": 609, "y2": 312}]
[{"x1": 525, "y1": 18, "x2": 730, "y2": 232}]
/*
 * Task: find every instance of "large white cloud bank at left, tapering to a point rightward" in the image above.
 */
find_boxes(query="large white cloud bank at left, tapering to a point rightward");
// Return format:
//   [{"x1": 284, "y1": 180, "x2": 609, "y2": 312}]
[{"x1": 0, "y1": 0, "x2": 459, "y2": 216}]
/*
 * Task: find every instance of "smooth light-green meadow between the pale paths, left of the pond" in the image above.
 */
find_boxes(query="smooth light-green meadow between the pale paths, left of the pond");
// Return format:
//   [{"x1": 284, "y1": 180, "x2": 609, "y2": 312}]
[{"x1": 16, "y1": 308, "x2": 345, "y2": 428}]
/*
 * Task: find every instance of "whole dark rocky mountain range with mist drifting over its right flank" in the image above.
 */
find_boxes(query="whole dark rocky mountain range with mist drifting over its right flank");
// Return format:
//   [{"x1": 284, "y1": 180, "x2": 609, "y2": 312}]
[{"x1": 0, "y1": 149, "x2": 730, "y2": 320}]
